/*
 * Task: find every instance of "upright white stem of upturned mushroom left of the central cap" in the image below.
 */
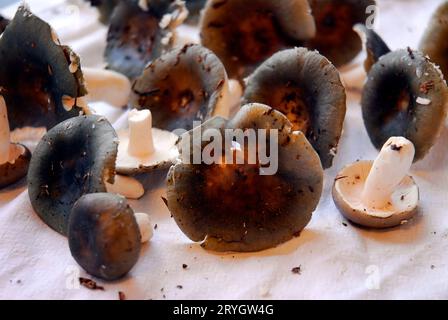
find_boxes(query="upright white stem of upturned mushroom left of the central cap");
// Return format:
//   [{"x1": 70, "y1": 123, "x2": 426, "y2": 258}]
[{"x1": 128, "y1": 109, "x2": 155, "y2": 157}]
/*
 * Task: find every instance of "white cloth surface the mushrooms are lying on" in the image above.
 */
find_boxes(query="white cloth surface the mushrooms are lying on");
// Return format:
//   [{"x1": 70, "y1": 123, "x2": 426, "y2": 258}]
[{"x1": 0, "y1": 0, "x2": 448, "y2": 299}]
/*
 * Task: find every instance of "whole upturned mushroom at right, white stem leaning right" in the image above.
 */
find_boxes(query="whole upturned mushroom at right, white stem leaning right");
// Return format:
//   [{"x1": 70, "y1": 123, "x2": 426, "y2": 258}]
[{"x1": 333, "y1": 137, "x2": 419, "y2": 228}]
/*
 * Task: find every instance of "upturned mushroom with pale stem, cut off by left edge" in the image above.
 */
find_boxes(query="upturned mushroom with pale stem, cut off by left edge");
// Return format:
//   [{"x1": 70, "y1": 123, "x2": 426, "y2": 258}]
[{"x1": 0, "y1": 95, "x2": 31, "y2": 189}]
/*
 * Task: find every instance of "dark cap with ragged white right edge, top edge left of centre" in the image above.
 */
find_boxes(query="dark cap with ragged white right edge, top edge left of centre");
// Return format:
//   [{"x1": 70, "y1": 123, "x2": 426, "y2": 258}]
[{"x1": 105, "y1": 0, "x2": 188, "y2": 79}]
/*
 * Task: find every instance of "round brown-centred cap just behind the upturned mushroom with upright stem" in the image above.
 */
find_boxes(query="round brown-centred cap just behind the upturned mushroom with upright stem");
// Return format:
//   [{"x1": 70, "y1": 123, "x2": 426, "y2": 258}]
[{"x1": 131, "y1": 45, "x2": 227, "y2": 131}]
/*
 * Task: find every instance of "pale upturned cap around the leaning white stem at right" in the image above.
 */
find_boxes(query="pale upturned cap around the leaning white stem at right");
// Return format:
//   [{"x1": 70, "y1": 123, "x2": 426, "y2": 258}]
[{"x1": 333, "y1": 161, "x2": 419, "y2": 228}]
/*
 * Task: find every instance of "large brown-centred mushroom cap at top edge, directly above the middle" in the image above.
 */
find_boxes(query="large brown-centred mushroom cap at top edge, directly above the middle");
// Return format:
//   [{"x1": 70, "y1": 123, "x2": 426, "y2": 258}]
[{"x1": 200, "y1": 0, "x2": 315, "y2": 80}]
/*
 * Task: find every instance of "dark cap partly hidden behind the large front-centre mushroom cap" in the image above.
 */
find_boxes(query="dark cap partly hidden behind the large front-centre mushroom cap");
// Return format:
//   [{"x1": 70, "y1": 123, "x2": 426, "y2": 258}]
[{"x1": 243, "y1": 48, "x2": 346, "y2": 168}]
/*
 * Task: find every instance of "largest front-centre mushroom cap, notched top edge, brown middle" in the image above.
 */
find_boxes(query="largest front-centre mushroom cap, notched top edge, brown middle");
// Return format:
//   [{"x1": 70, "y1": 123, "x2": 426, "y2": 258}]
[{"x1": 167, "y1": 104, "x2": 323, "y2": 252}]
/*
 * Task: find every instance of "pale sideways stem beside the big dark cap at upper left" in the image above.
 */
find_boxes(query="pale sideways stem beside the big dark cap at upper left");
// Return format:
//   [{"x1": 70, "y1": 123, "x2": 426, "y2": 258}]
[{"x1": 83, "y1": 68, "x2": 132, "y2": 108}]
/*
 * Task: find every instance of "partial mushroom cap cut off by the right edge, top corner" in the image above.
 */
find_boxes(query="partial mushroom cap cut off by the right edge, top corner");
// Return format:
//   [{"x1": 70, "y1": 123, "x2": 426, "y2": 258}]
[{"x1": 420, "y1": 1, "x2": 448, "y2": 77}]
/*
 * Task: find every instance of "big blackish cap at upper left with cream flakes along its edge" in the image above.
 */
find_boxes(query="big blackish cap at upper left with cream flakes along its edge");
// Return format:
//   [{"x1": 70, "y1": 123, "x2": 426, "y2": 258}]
[{"x1": 0, "y1": 6, "x2": 88, "y2": 130}]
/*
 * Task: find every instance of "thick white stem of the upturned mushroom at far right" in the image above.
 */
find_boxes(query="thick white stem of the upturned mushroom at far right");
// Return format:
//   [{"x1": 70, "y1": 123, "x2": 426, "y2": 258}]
[{"x1": 361, "y1": 137, "x2": 415, "y2": 209}]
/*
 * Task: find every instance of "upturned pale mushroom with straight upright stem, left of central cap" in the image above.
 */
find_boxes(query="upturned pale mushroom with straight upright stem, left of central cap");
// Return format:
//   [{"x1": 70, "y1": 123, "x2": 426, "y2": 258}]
[{"x1": 117, "y1": 109, "x2": 179, "y2": 175}]
